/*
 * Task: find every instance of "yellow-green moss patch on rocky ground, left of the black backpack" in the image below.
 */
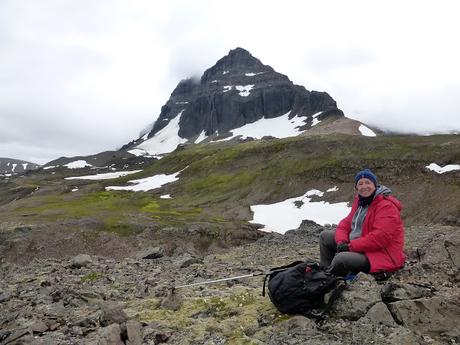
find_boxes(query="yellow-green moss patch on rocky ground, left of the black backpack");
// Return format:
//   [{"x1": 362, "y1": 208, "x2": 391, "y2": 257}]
[{"x1": 126, "y1": 287, "x2": 281, "y2": 344}]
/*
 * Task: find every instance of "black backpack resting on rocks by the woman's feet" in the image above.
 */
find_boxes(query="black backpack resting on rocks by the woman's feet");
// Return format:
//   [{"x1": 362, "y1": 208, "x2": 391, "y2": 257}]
[{"x1": 262, "y1": 261, "x2": 345, "y2": 318}]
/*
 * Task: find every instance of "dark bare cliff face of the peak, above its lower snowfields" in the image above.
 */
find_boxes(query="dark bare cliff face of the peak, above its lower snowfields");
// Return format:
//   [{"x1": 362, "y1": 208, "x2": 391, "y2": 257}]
[{"x1": 148, "y1": 48, "x2": 343, "y2": 139}]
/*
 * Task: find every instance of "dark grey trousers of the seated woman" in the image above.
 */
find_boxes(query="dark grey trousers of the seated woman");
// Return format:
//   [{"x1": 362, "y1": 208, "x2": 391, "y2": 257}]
[{"x1": 319, "y1": 230, "x2": 371, "y2": 277}]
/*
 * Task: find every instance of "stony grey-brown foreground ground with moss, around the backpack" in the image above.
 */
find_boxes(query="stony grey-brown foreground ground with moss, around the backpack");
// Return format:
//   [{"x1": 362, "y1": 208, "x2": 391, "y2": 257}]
[{"x1": 0, "y1": 222, "x2": 460, "y2": 345}]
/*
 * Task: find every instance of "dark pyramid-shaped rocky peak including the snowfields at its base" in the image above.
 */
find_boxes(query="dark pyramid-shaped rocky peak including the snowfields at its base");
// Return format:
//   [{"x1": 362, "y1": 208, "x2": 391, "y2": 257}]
[{"x1": 123, "y1": 48, "x2": 359, "y2": 154}]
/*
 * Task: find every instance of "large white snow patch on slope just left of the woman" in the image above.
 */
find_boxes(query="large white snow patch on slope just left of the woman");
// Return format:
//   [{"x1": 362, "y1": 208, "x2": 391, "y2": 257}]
[{"x1": 250, "y1": 187, "x2": 350, "y2": 234}]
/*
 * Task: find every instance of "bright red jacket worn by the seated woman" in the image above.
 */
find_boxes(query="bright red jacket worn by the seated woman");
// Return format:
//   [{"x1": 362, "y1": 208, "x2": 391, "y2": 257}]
[{"x1": 335, "y1": 194, "x2": 405, "y2": 273}]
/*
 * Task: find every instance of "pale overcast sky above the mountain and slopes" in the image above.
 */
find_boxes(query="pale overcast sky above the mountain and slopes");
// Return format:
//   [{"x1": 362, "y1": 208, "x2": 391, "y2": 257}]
[{"x1": 0, "y1": 0, "x2": 460, "y2": 163}]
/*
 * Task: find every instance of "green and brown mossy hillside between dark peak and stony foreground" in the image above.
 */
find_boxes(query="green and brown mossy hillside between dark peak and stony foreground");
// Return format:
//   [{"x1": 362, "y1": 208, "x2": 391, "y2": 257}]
[{"x1": 0, "y1": 135, "x2": 460, "y2": 260}]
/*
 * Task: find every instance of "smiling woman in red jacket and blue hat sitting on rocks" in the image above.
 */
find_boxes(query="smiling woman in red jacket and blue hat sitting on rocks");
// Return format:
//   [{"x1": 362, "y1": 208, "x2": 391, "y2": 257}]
[{"x1": 319, "y1": 169, "x2": 405, "y2": 276}]
